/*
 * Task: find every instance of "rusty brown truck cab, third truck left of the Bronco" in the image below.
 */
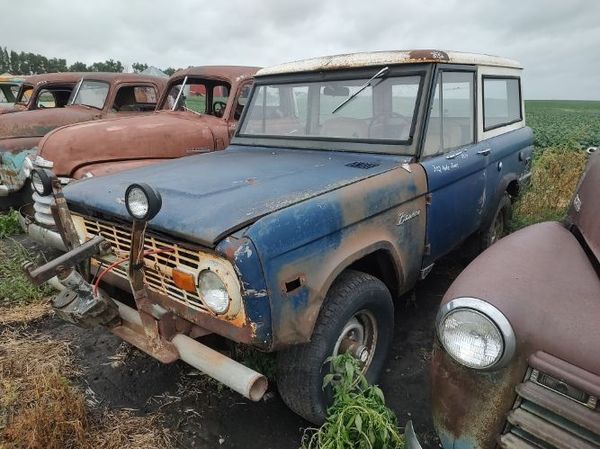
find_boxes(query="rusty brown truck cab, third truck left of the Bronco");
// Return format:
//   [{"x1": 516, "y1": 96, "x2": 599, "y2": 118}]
[{"x1": 0, "y1": 72, "x2": 85, "y2": 114}]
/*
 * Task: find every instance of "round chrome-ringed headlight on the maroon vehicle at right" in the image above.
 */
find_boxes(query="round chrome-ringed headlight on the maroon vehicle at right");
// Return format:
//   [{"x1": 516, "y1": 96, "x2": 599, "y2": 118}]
[{"x1": 437, "y1": 298, "x2": 516, "y2": 370}]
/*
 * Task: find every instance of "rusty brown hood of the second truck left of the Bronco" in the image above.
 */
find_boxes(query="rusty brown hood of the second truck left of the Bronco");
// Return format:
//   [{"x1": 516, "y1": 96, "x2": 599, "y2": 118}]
[{"x1": 0, "y1": 106, "x2": 101, "y2": 143}]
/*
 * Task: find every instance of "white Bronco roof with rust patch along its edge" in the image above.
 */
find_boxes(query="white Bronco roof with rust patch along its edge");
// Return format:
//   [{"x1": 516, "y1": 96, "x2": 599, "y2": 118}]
[{"x1": 256, "y1": 50, "x2": 522, "y2": 76}]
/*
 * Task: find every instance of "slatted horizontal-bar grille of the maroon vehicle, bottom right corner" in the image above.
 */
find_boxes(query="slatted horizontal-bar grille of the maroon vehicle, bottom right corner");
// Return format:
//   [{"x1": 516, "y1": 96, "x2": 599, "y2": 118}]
[{"x1": 499, "y1": 356, "x2": 600, "y2": 449}]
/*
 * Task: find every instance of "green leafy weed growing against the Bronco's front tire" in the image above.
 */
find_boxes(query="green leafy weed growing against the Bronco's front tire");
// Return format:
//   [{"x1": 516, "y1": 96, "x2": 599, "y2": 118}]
[{"x1": 302, "y1": 354, "x2": 405, "y2": 449}]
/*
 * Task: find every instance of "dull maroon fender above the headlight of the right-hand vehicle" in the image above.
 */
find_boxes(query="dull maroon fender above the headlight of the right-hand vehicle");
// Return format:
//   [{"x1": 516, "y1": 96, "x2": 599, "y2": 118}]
[{"x1": 442, "y1": 222, "x2": 600, "y2": 375}]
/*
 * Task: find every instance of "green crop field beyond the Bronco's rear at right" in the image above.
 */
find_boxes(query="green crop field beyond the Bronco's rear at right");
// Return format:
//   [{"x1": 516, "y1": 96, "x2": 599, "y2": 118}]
[{"x1": 525, "y1": 100, "x2": 600, "y2": 148}]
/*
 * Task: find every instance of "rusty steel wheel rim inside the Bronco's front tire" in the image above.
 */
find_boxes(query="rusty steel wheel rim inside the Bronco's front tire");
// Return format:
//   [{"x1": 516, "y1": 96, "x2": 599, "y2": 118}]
[{"x1": 332, "y1": 310, "x2": 378, "y2": 374}]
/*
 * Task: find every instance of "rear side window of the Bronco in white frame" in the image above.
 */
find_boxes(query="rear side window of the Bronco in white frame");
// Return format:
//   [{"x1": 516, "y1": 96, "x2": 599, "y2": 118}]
[{"x1": 483, "y1": 76, "x2": 522, "y2": 131}]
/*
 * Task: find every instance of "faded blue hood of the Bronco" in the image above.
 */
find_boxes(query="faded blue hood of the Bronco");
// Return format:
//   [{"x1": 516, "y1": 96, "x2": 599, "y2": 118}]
[{"x1": 65, "y1": 146, "x2": 407, "y2": 246}]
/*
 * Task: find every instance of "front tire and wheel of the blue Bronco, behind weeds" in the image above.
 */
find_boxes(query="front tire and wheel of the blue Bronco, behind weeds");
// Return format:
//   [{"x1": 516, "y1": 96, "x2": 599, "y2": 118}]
[{"x1": 277, "y1": 270, "x2": 394, "y2": 425}]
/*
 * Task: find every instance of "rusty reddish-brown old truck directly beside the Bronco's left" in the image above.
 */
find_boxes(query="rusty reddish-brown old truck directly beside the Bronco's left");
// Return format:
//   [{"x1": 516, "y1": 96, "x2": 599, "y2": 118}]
[{"x1": 20, "y1": 66, "x2": 258, "y2": 249}]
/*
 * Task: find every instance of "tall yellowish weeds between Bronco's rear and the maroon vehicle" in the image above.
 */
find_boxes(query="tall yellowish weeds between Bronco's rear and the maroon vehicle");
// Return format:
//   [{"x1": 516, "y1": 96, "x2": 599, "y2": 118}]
[{"x1": 512, "y1": 148, "x2": 587, "y2": 230}]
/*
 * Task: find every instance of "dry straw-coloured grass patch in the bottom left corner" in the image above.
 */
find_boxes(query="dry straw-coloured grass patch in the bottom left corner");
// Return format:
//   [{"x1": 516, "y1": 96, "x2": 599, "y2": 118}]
[{"x1": 0, "y1": 330, "x2": 172, "y2": 449}]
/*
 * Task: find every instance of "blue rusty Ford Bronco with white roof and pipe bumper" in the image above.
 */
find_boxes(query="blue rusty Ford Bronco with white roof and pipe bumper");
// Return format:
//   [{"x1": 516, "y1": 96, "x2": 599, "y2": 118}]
[{"x1": 30, "y1": 50, "x2": 533, "y2": 423}]
